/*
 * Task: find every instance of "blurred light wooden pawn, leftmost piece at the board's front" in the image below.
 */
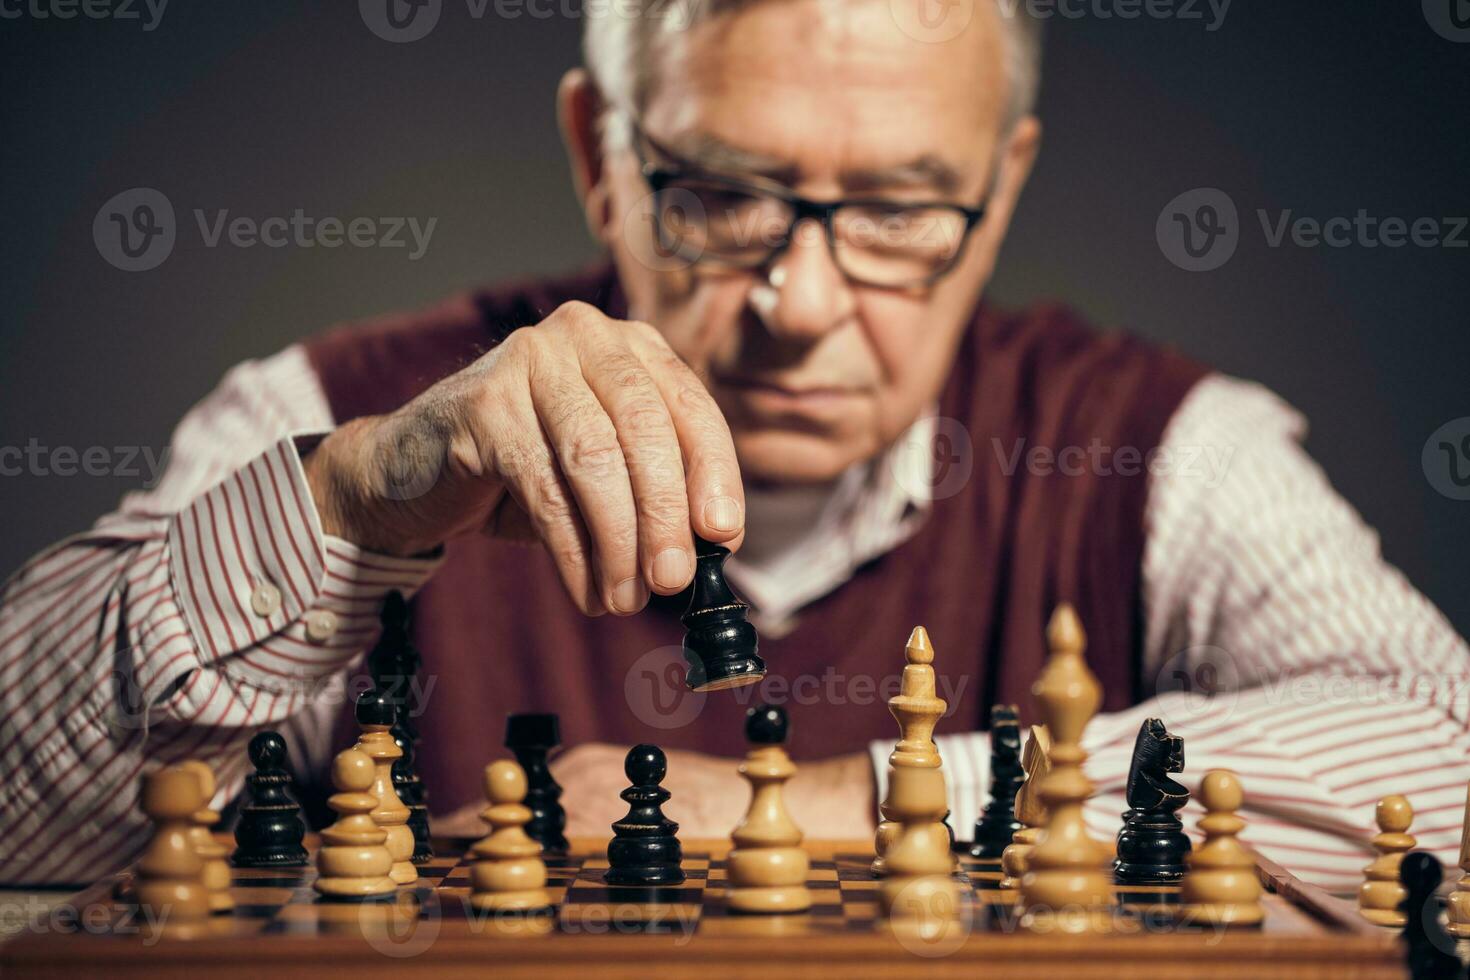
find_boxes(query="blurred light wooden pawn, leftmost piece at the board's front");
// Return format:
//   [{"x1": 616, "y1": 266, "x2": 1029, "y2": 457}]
[{"x1": 137, "y1": 765, "x2": 209, "y2": 934}]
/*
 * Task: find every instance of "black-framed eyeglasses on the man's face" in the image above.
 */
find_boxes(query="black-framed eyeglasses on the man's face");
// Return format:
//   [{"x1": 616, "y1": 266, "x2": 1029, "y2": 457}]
[{"x1": 632, "y1": 123, "x2": 985, "y2": 289}]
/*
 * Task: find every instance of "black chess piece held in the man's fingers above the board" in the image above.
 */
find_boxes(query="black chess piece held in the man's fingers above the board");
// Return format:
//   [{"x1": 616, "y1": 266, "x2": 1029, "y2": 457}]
[{"x1": 682, "y1": 538, "x2": 766, "y2": 691}]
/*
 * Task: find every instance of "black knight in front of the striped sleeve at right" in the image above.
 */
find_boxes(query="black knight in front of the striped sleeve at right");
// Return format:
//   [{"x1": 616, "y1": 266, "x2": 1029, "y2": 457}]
[{"x1": 1113, "y1": 718, "x2": 1189, "y2": 884}]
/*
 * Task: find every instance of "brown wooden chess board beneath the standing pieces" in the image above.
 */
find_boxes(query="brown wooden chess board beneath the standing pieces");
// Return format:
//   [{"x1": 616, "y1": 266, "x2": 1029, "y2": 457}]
[{"x1": 0, "y1": 839, "x2": 1405, "y2": 980}]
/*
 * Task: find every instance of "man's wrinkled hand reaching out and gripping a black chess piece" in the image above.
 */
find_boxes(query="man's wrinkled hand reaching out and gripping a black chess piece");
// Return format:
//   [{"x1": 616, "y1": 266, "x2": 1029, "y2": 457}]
[{"x1": 306, "y1": 303, "x2": 745, "y2": 616}]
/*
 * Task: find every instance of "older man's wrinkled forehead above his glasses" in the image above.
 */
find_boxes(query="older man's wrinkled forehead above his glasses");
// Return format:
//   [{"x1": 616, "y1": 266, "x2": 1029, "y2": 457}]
[{"x1": 642, "y1": 0, "x2": 1007, "y2": 191}]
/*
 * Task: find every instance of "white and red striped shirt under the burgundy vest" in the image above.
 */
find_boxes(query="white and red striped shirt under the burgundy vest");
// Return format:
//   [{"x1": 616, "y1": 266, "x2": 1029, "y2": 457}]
[{"x1": 0, "y1": 339, "x2": 1470, "y2": 889}]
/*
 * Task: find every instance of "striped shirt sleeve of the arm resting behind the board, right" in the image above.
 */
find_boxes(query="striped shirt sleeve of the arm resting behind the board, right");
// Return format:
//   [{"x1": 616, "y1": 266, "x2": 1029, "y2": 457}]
[{"x1": 870, "y1": 376, "x2": 1470, "y2": 892}]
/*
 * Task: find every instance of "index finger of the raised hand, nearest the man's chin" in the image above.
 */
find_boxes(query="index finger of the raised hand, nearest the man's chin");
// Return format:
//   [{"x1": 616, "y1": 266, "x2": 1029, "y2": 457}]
[{"x1": 629, "y1": 323, "x2": 745, "y2": 550}]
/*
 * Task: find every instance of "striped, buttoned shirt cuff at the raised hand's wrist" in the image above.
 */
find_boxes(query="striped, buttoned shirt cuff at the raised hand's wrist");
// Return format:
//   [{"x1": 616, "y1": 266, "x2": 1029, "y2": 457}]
[{"x1": 169, "y1": 433, "x2": 441, "y2": 693}]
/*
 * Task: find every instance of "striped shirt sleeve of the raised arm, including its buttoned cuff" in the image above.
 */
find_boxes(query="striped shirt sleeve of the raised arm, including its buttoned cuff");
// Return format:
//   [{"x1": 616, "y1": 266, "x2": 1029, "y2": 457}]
[{"x1": 0, "y1": 347, "x2": 438, "y2": 883}]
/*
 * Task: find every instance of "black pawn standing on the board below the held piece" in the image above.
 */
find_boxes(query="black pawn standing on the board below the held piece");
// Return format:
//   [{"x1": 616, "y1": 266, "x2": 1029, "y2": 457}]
[{"x1": 603, "y1": 745, "x2": 684, "y2": 886}]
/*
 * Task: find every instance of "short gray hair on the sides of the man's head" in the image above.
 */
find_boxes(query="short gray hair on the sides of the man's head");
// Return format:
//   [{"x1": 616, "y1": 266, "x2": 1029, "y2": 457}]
[{"x1": 582, "y1": 0, "x2": 1042, "y2": 144}]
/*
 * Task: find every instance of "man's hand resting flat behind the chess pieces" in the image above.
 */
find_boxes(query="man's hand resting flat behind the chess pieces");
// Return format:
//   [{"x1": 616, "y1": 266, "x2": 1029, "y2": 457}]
[{"x1": 434, "y1": 742, "x2": 876, "y2": 840}]
